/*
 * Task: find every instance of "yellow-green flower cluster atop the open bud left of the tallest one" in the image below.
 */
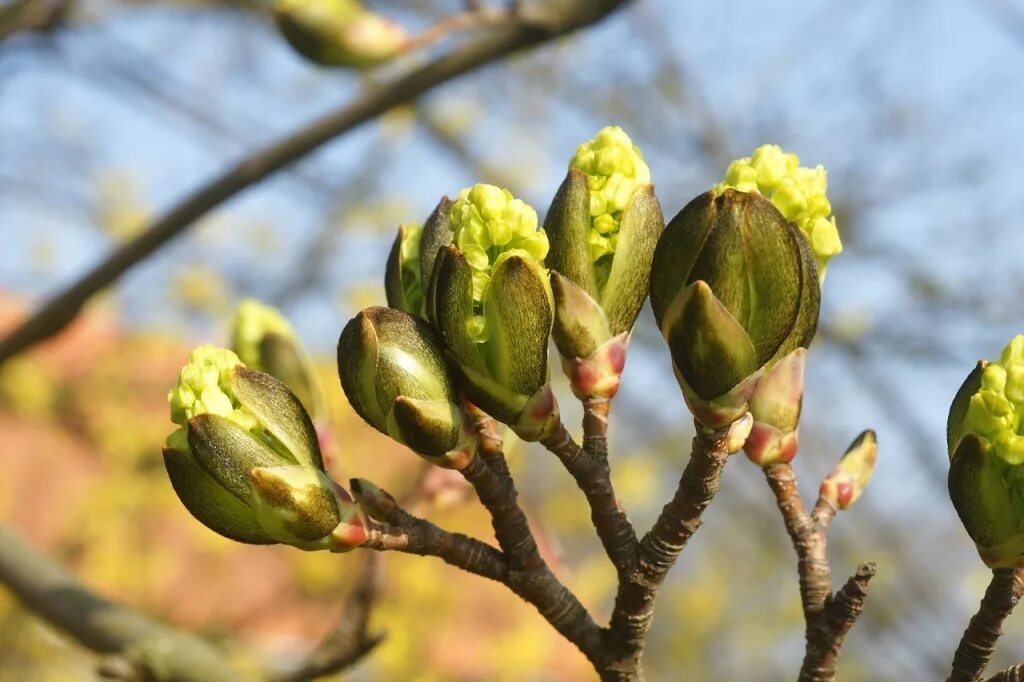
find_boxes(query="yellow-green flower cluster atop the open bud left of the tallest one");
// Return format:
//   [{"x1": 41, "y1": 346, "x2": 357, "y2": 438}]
[{"x1": 449, "y1": 184, "x2": 548, "y2": 333}]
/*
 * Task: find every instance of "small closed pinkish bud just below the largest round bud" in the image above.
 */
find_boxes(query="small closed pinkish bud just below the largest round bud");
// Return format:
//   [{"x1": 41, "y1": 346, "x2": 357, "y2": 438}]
[{"x1": 743, "y1": 348, "x2": 807, "y2": 467}]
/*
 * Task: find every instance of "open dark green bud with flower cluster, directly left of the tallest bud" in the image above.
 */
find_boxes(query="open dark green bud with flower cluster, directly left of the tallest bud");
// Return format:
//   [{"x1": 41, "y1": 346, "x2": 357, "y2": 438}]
[{"x1": 428, "y1": 184, "x2": 554, "y2": 437}]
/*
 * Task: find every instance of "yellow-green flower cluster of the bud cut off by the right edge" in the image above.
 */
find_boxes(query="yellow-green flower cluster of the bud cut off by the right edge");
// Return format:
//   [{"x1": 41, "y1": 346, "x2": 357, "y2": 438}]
[{"x1": 967, "y1": 336, "x2": 1024, "y2": 465}]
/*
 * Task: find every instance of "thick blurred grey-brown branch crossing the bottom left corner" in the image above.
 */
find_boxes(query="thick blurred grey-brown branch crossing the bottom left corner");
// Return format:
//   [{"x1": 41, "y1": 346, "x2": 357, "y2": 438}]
[{"x1": 0, "y1": 525, "x2": 246, "y2": 682}]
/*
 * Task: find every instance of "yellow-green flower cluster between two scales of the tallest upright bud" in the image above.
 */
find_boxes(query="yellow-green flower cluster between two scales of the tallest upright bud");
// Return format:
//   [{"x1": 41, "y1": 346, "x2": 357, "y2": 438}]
[{"x1": 569, "y1": 126, "x2": 650, "y2": 262}]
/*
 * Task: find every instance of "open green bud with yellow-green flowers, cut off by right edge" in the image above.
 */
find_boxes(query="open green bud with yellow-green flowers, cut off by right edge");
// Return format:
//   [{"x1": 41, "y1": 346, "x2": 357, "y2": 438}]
[{"x1": 946, "y1": 336, "x2": 1024, "y2": 568}]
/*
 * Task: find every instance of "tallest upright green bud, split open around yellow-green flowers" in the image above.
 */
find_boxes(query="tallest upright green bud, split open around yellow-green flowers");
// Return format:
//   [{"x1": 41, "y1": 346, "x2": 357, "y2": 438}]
[{"x1": 545, "y1": 127, "x2": 665, "y2": 359}]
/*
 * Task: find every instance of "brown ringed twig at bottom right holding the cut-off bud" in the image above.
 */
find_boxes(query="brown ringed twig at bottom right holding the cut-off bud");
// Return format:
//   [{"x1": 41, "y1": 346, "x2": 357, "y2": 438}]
[{"x1": 947, "y1": 568, "x2": 1024, "y2": 682}]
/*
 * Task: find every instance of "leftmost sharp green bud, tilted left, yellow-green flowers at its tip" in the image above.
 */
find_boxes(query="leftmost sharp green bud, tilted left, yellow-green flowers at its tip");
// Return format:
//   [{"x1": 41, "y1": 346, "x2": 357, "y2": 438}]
[{"x1": 164, "y1": 346, "x2": 348, "y2": 550}]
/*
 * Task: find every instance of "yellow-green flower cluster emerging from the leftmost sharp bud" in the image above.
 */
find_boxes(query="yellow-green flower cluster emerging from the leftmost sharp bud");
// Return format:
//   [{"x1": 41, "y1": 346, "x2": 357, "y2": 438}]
[{"x1": 167, "y1": 345, "x2": 260, "y2": 453}]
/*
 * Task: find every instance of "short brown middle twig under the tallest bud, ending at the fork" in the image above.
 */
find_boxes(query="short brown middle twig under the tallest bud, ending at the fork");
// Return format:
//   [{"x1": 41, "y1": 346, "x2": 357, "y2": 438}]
[{"x1": 542, "y1": 413, "x2": 637, "y2": 576}]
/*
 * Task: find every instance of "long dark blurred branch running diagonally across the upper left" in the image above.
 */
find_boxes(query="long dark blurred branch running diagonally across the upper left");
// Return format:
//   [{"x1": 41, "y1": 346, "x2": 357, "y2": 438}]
[{"x1": 0, "y1": 0, "x2": 628, "y2": 364}]
